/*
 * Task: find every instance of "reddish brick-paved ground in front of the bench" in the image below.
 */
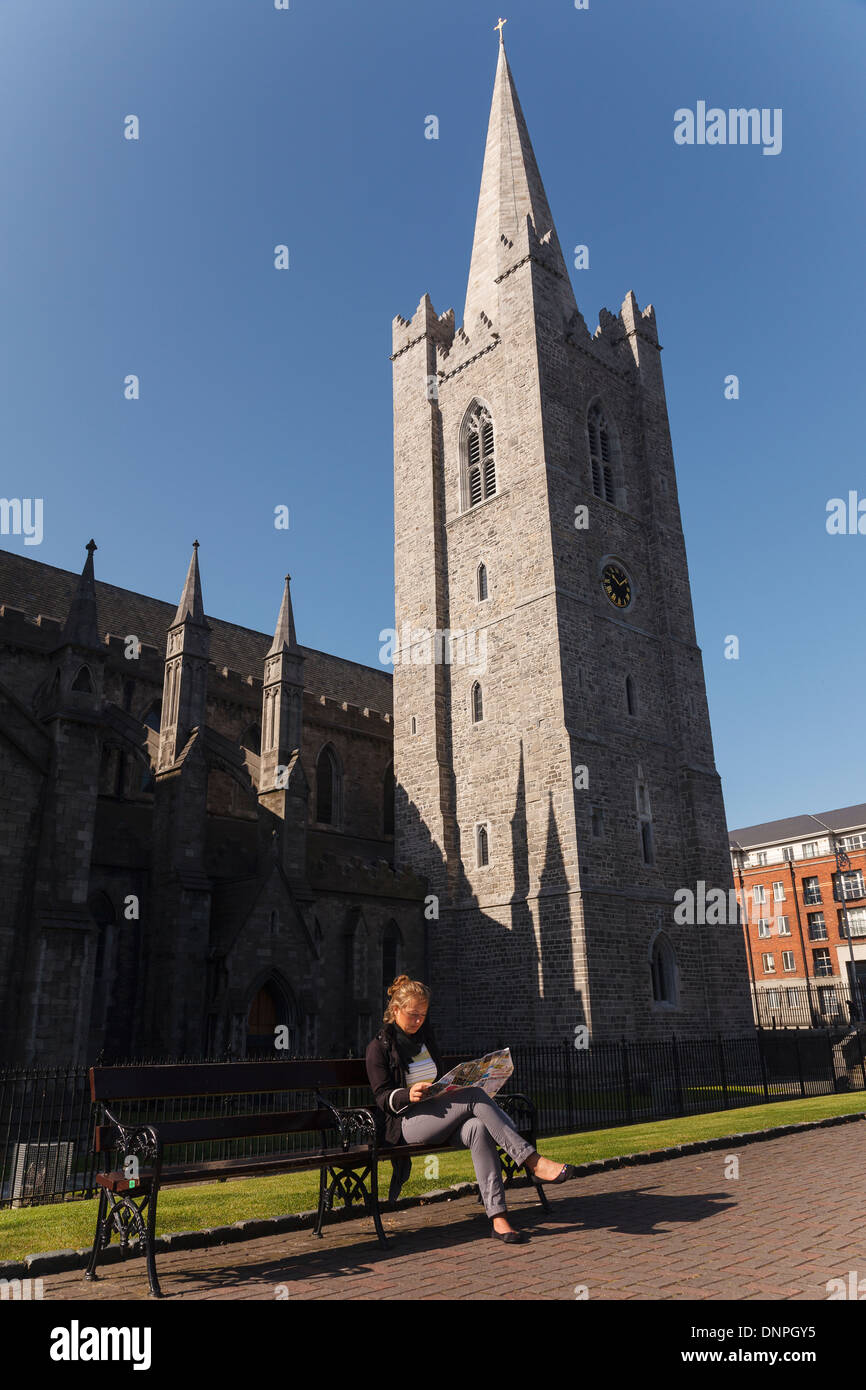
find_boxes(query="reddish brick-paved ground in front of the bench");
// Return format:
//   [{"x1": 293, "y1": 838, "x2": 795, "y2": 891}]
[{"x1": 33, "y1": 1123, "x2": 866, "y2": 1301}]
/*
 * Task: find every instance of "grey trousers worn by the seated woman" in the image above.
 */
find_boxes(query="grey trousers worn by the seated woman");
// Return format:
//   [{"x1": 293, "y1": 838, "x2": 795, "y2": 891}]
[{"x1": 402, "y1": 1086, "x2": 535, "y2": 1216}]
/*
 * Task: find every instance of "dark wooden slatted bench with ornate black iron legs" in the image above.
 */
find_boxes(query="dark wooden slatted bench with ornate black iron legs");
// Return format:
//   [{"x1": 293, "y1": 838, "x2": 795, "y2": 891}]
[{"x1": 85, "y1": 1056, "x2": 549, "y2": 1298}]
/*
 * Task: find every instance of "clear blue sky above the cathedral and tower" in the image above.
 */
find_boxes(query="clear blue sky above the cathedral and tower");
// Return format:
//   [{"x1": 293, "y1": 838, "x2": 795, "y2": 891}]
[{"x1": 0, "y1": 0, "x2": 866, "y2": 827}]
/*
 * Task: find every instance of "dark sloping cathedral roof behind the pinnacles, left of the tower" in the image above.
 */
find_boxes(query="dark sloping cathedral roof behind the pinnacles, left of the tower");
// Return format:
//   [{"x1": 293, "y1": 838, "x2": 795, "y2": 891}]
[{"x1": 0, "y1": 549, "x2": 392, "y2": 713}]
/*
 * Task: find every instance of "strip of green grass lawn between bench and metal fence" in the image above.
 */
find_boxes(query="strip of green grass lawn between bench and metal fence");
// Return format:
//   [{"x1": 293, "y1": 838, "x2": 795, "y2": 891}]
[{"x1": 0, "y1": 1091, "x2": 866, "y2": 1259}]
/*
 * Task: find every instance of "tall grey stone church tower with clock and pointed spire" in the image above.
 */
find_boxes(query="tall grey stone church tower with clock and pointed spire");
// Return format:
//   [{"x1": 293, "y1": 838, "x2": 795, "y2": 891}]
[{"x1": 392, "y1": 38, "x2": 752, "y2": 1047}]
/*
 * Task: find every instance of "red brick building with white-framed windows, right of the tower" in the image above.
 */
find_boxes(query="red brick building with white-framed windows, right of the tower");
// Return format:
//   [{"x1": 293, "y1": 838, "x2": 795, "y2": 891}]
[{"x1": 728, "y1": 805, "x2": 866, "y2": 1027}]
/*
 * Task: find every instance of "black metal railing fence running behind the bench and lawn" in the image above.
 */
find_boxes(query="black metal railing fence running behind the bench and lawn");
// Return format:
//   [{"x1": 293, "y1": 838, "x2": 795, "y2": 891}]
[{"x1": 0, "y1": 1029, "x2": 866, "y2": 1208}]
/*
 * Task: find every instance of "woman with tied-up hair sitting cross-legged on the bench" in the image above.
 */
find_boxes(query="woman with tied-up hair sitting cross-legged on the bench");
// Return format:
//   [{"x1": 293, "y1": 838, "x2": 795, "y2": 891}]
[{"x1": 366, "y1": 974, "x2": 574, "y2": 1245}]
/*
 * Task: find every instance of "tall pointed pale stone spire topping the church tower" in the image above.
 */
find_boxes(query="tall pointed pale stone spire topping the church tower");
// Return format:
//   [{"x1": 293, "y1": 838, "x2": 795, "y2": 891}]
[{"x1": 463, "y1": 38, "x2": 577, "y2": 338}]
